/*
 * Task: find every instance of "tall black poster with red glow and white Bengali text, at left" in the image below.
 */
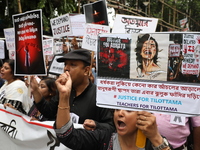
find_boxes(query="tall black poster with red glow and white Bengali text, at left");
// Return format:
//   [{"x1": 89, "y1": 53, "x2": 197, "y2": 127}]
[{"x1": 13, "y1": 10, "x2": 46, "y2": 75}]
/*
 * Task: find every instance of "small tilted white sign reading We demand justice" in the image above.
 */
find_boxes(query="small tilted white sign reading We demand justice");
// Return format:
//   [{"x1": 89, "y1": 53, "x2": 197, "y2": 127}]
[{"x1": 50, "y1": 14, "x2": 72, "y2": 38}]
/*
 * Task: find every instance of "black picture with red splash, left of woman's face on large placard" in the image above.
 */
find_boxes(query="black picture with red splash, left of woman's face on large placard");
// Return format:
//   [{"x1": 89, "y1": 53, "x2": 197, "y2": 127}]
[{"x1": 98, "y1": 35, "x2": 131, "y2": 78}]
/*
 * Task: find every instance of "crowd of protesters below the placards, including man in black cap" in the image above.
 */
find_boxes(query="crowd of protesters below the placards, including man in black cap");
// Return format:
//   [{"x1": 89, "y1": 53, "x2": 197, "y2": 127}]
[{"x1": 0, "y1": 42, "x2": 200, "y2": 150}]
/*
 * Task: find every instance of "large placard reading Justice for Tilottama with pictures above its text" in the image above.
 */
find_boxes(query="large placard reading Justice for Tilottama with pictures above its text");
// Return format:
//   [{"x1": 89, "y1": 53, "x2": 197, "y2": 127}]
[{"x1": 97, "y1": 32, "x2": 200, "y2": 116}]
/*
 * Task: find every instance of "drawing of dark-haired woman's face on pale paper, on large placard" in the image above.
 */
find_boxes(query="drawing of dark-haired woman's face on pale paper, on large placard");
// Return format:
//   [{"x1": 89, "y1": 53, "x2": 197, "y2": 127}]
[{"x1": 130, "y1": 34, "x2": 170, "y2": 81}]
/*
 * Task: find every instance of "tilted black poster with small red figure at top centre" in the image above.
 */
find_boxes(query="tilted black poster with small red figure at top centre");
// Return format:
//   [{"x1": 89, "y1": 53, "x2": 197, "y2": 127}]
[{"x1": 83, "y1": 0, "x2": 108, "y2": 25}]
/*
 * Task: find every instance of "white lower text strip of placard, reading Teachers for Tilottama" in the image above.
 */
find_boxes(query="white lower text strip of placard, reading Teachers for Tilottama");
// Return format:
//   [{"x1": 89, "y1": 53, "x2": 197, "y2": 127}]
[{"x1": 97, "y1": 79, "x2": 200, "y2": 116}]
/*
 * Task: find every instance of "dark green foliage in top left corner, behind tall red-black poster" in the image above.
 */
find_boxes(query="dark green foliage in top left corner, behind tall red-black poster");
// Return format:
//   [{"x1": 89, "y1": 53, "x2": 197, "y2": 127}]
[{"x1": 0, "y1": 0, "x2": 76, "y2": 37}]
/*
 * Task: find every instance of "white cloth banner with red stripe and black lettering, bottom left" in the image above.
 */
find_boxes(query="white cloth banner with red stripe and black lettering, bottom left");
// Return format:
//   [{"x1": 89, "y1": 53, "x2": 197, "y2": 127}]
[{"x1": 0, "y1": 105, "x2": 82, "y2": 150}]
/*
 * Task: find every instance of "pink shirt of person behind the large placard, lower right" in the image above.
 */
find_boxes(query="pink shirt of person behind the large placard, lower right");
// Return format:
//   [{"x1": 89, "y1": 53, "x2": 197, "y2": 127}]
[{"x1": 154, "y1": 114, "x2": 200, "y2": 148}]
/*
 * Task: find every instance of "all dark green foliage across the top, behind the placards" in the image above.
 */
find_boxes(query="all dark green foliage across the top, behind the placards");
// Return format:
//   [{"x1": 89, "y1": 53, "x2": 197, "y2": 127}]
[{"x1": 0, "y1": 0, "x2": 200, "y2": 37}]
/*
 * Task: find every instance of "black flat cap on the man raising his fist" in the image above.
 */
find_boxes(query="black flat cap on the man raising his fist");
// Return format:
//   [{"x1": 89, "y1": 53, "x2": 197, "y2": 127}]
[{"x1": 57, "y1": 49, "x2": 91, "y2": 64}]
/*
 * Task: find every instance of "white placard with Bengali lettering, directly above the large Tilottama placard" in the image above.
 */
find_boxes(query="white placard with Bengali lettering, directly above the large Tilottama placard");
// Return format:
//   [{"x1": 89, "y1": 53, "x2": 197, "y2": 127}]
[{"x1": 112, "y1": 14, "x2": 158, "y2": 34}]
